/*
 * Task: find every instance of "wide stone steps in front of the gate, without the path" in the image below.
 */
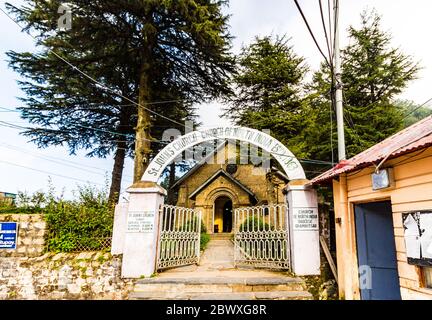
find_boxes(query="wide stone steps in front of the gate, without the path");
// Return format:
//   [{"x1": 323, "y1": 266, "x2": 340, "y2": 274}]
[{"x1": 130, "y1": 276, "x2": 312, "y2": 300}]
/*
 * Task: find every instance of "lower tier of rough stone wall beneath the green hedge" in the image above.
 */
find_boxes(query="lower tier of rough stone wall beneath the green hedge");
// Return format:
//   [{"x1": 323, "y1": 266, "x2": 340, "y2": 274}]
[{"x1": 0, "y1": 252, "x2": 134, "y2": 300}]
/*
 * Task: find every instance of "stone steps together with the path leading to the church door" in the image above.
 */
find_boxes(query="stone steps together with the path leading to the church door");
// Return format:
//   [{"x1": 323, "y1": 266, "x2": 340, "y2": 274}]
[{"x1": 129, "y1": 239, "x2": 312, "y2": 300}]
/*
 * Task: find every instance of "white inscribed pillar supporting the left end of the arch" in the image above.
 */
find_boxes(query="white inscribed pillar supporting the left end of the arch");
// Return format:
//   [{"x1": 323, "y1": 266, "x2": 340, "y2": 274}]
[{"x1": 122, "y1": 181, "x2": 166, "y2": 278}]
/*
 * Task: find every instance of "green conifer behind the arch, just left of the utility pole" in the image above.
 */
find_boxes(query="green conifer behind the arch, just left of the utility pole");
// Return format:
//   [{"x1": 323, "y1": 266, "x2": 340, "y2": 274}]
[{"x1": 225, "y1": 37, "x2": 307, "y2": 155}]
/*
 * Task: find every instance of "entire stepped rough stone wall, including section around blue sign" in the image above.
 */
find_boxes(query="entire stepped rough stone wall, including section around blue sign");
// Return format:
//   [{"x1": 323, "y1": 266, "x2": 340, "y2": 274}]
[{"x1": 0, "y1": 214, "x2": 134, "y2": 300}]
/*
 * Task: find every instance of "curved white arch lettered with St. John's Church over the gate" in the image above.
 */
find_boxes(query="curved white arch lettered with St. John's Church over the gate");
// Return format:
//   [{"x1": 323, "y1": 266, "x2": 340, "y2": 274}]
[{"x1": 141, "y1": 127, "x2": 306, "y2": 182}]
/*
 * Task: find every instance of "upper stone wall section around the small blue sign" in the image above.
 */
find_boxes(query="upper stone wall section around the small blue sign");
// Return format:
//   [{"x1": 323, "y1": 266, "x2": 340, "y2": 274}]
[{"x1": 0, "y1": 214, "x2": 46, "y2": 258}]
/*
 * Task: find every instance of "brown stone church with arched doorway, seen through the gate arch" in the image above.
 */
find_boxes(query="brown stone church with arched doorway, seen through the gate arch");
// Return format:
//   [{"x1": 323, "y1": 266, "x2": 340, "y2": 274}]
[{"x1": 170, "y1": 142, "x2": 288, "y2": 233}]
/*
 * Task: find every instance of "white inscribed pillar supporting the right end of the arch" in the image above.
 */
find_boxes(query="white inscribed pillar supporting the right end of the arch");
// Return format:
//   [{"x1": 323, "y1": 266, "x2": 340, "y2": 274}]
[{"x1": 286, "y1": 180, "x2": 320, "y2": 275}]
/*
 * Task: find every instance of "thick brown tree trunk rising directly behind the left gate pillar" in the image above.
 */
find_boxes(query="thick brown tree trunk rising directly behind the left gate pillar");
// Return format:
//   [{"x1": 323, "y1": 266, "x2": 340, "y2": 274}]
[{"x1": 134, "y1": 68, "x2": 151, "y2": 183}]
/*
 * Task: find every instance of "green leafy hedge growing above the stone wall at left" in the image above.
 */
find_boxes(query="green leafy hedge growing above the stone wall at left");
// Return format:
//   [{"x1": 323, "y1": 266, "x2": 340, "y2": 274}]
[{"x1": 0, "y1": 182, "x2": 114, "y2": 252}]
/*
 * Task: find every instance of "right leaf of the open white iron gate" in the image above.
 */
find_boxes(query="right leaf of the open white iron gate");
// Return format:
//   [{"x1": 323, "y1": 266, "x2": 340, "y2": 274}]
[{"x1": 234, "y1": 204, "x2": 291, "y2": 269}]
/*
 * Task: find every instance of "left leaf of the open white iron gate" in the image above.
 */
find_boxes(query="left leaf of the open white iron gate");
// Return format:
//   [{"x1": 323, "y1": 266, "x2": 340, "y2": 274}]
[{"x1": 156, "y1": 205, "x2": 201, "y2": 270}]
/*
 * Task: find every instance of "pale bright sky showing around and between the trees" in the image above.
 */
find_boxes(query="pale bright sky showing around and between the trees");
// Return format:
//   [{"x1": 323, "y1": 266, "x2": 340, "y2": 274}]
[{"x1": 0, "y1": 0, "x2": 432, "y2": 198}]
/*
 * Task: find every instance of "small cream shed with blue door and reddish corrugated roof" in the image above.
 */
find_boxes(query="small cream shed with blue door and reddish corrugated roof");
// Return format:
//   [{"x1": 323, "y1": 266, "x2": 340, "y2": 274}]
[{"x1": 310, "y1": 116, "x2": 432, "y2": 300}]
